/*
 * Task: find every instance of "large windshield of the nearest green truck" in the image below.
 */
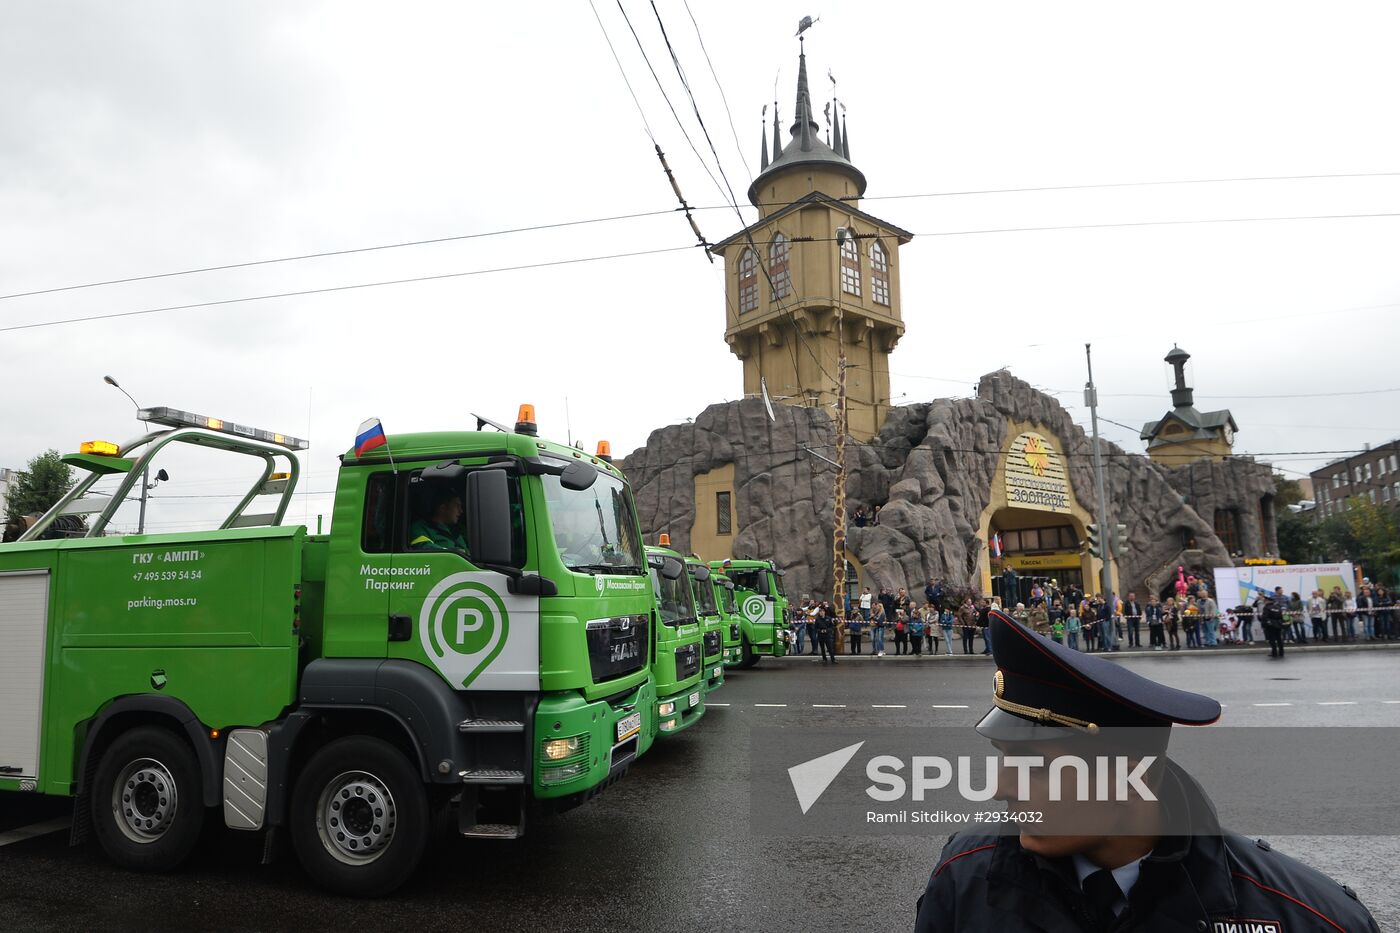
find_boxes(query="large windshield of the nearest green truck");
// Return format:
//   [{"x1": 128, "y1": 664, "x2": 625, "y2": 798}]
[{"x1": 540, "y1": 472, "x2": 643, "y2": 573}]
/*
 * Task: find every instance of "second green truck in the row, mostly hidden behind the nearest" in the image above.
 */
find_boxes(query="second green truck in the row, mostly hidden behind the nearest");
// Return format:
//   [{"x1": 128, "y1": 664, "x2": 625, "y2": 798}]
[{"x1": 647, "y1": 535, "x2": 704, "y2": 735}]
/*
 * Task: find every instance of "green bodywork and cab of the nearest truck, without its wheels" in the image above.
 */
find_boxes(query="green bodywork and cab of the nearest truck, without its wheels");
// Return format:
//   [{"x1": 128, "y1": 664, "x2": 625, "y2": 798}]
[{"x1": 0, "y1": 431, "x2": 655, "y2": 818}]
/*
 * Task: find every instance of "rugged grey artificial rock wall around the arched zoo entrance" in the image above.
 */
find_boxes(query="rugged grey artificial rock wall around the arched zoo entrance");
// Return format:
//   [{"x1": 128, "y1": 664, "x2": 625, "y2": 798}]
[{"x1": 620, "y1": 371, "x2": 1277, "y2": 594}]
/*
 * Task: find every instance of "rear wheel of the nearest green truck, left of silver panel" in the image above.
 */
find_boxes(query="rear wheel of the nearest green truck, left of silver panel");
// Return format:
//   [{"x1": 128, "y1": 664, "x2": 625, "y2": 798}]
[{"x1": 90, "y1": 726, "x2": 204, "y2": 871}]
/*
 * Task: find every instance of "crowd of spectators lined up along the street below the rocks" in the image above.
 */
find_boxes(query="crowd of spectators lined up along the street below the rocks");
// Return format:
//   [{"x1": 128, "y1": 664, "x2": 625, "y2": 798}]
[{"x1": 788, "y1": 571, "x2": 1400, "y2": 664}]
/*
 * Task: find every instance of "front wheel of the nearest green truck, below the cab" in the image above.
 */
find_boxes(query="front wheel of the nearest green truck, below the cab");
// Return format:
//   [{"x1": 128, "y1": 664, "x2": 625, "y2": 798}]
[{"x1": 291, "y1": 735, "x2": 430, "y2": 898}]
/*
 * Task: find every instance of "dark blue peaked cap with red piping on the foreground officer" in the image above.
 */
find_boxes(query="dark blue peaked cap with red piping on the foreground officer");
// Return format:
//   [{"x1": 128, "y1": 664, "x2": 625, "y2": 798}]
[{"x1": 977, "y1": 609, "x2": 1221, "y2": 741}]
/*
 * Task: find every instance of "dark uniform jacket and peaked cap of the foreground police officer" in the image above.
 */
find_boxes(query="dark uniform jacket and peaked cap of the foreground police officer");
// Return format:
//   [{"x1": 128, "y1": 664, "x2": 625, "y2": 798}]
[{"x1": 914, "y1": 611, "x2": 1379, "y2": 933}]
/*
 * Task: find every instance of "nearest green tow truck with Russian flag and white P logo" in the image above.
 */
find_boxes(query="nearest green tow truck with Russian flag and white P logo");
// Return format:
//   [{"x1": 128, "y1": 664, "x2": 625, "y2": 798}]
[{"x1": 0, "y1": 406, "x2": 655, "y2": 895}]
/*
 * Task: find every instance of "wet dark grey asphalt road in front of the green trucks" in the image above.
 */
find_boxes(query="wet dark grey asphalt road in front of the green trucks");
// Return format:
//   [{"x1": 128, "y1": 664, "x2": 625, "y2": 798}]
[{"x1": 0, "y1": 650, "x2": 1400, "y2": 933}]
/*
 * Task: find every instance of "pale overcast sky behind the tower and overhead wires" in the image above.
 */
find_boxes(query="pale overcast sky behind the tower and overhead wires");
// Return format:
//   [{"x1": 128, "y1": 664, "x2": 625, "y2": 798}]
[{"x1": 0, "y1": 0, "x2": 1400, "y2": 530}]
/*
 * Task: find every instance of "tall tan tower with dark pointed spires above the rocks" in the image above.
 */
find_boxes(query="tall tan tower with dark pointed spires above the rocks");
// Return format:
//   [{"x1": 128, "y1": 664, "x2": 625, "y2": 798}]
[{"x1": 713, "y1": 39, "x2": 913, "y2": 440}]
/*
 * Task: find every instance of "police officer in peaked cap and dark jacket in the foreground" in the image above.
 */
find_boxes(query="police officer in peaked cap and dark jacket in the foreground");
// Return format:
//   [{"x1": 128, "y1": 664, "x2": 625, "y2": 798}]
[{"x1": 914, "y1": 611, "x2": 1379, "y2": 933}]
